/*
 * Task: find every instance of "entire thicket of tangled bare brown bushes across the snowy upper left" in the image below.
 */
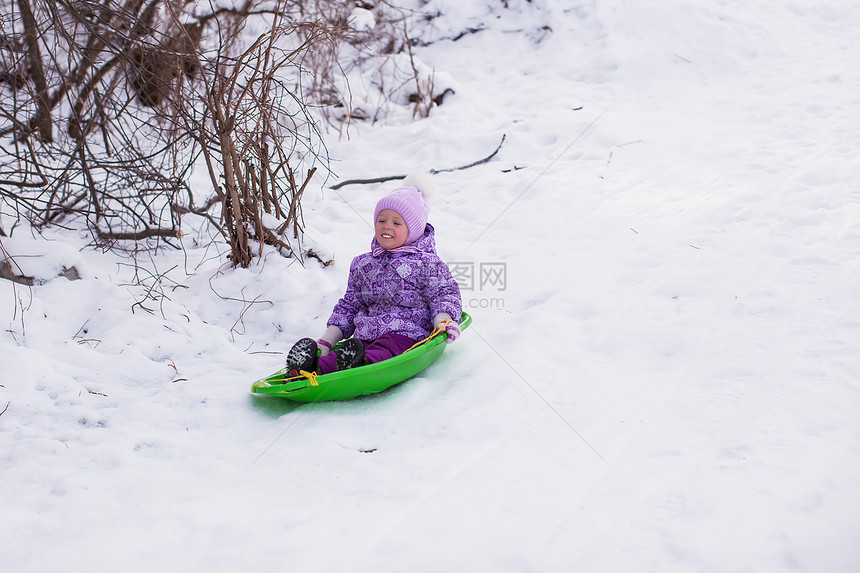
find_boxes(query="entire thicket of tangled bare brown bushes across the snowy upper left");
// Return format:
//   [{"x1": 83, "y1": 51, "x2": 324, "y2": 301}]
[{"x1": 0, "y1": 0, "x2": 450, "y2": 265}]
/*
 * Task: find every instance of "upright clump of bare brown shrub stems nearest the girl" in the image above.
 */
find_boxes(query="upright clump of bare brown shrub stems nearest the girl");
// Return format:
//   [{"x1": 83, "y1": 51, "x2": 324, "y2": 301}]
[{"x1": 191, "y1": 20, "x2": 330, "y2": 266}]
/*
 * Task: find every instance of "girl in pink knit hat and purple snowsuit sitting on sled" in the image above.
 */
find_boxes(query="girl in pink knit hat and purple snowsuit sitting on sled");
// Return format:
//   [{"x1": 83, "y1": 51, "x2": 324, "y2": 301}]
[{"x1": 287, "y1": 179, "x2": 462, "y2": 376}]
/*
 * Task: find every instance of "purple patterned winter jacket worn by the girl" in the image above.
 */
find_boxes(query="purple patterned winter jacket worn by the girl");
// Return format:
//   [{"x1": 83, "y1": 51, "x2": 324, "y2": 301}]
[{"x1": 327, "y1": 223, "x2": 462, "y2": 341}]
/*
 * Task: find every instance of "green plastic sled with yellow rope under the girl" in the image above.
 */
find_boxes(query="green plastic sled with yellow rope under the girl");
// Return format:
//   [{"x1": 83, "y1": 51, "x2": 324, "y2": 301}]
[{"x1": 251, "y1": 312, "x2": 472, "y2": 402}]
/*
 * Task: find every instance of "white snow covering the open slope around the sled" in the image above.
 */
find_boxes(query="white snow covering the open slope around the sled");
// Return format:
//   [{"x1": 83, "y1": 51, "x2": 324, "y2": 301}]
[{"x1": 0, "y1": 0, "x2": 860, "y2": 573}]
